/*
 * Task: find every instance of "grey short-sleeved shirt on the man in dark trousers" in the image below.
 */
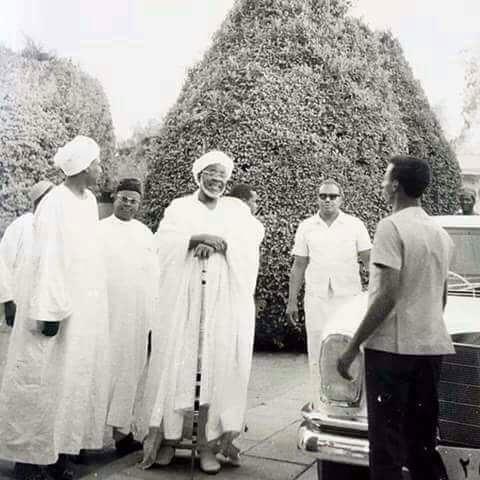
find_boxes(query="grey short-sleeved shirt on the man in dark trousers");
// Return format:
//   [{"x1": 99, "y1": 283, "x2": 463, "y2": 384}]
[{"x1": 365, "y1": 207, "x2": 454, "y2": 355}]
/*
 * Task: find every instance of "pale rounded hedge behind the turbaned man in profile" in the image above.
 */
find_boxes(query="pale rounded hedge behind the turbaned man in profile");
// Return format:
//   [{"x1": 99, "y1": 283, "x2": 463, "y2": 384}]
[{"x1": 0, "y1": 43, "x2": 115, "y2": 235}]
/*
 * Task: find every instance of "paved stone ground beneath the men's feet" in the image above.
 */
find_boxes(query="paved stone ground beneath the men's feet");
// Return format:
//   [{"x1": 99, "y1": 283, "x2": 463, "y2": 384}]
[{"x1": 0, "y1": 332, "x2": 317, "y2": 480}]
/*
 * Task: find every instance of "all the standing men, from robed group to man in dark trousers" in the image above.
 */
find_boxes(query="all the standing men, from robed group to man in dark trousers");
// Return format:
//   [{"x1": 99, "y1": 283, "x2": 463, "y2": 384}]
[{"x1": 0, "y1": 132, "x2": 458, "y2": 480}]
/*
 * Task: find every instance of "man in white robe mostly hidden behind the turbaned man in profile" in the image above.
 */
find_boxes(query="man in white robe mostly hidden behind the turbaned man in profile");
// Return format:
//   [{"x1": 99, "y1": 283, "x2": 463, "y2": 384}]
[{"x1": 0, "y1": 180, "x2": 54, "y2": 316}]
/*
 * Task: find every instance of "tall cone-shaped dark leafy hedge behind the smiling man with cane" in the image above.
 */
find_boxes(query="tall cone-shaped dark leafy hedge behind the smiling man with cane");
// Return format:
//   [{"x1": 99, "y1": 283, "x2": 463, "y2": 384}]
[{"x1": 143, "y1": 0, "x2": 459, "y2": 344}]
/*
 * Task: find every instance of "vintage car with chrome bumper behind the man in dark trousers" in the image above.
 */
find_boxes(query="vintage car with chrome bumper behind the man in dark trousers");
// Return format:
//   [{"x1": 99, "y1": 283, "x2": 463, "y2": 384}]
[{"x1": 298, "y1": 216, "x2": 480, "y2": 480}]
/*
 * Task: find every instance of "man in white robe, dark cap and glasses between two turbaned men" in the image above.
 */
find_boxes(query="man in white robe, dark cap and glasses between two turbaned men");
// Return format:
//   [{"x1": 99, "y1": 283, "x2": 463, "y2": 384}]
[{"x1": 100, "y1": 178, "x2": 158, "y2": 454}]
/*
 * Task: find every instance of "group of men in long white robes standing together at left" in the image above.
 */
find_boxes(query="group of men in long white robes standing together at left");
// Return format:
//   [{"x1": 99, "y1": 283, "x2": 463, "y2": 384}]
[{"x1": 0, "y1": 136, "x2": 263, "y2": 480}]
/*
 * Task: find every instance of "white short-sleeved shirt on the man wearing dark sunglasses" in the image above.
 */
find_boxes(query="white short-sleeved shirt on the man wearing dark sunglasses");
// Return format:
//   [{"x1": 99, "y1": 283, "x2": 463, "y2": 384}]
[{"x1": 292, "y1": 212, "x2": 372, "y2": 298}]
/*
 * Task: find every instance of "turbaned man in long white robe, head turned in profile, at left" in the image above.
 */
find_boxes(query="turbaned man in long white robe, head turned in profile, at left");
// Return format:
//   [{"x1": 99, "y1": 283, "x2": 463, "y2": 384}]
[{"x1": 0, "y1": 136, "x2": 109, "y2": 480}]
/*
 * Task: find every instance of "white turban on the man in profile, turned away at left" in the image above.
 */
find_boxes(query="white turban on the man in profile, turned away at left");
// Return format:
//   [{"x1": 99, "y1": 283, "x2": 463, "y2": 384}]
[{"x1": 53, "y1": 135, "x2": 100, "y2": 177}]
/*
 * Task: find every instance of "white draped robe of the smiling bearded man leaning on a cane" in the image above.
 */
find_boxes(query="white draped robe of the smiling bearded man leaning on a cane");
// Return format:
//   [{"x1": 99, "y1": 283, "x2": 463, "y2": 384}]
[{"x1": 137, "y1": 192, "x2": 264, "y2": 466}]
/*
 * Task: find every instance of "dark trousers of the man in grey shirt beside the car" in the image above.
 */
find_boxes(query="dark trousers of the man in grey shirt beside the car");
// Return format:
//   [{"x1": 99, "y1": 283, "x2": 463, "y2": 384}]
[{"x1": 365, "y1": 349, "x2": 447, "y2": 480}]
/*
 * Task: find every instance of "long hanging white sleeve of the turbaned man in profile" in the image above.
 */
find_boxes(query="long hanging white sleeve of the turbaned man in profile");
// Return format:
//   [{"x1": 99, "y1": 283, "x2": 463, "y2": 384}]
[{"x1": 28, "y1": 191, "x2": 73, "y2": 322}]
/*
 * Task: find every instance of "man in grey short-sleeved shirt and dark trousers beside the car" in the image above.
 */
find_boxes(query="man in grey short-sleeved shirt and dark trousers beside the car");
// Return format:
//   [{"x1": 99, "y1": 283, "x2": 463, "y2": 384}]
[{"x1": 338, "y1": 156, "x2": 454, "y2": 480}]
